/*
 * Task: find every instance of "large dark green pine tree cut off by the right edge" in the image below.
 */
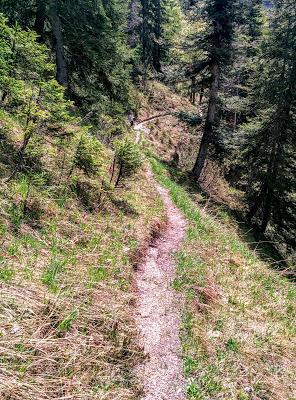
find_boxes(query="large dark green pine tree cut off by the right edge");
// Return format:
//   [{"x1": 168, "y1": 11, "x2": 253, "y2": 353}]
[{"x1": 243, "y1": 1, "x2": 296, "y2": 246}]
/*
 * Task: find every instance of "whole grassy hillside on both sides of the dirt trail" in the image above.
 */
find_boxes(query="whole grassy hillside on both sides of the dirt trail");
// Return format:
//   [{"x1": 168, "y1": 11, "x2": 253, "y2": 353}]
[{"x1": 0, "y1": 84, "x2": 296, "y2": 400}]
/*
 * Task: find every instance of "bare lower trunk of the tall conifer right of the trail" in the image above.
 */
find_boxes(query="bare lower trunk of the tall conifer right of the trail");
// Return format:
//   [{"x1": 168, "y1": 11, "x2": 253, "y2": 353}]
[{"x1": 192, "y1": 63, "x2": 220, "y2": 180}]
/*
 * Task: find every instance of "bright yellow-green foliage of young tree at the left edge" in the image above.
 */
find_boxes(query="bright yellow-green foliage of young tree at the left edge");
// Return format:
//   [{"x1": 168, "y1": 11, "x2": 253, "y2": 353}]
[{"x1": 0, "y1": 15, "x2": 78, "y2": 181}]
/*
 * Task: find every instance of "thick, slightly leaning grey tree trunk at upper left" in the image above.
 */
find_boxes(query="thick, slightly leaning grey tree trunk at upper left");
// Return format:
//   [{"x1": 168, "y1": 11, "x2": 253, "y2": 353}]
[{"x1": 49, "y1": 0, "x2": 68, "y2": 87}]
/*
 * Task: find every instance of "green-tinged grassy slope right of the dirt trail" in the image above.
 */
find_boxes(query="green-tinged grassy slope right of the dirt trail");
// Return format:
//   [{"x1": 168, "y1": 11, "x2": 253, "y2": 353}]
[{"x1": 152, "y1": 160, "x2": 296, "y2": 400}]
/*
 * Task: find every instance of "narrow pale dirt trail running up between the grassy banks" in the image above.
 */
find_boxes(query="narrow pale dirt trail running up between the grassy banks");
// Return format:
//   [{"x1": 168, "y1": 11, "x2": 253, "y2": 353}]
[{"x1": 135, "y1": 172, "x2": 186, "y2": 400}]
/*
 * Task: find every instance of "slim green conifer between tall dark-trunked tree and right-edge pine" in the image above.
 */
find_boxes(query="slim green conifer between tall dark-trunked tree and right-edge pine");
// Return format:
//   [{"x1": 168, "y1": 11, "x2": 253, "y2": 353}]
[{"x1": 217, "y1": 0, "x2": 266, "y2": 172}]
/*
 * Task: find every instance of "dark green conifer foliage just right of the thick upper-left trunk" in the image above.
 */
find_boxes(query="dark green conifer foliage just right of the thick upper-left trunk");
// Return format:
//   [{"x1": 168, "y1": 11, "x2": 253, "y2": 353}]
[{"x1": 61, "y1": 0, "x2": 131, "y2": 111}]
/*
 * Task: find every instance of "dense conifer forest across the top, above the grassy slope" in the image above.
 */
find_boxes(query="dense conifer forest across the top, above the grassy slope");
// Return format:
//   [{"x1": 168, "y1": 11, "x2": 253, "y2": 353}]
[{"x1": 1, "y1": 0, "x2": 296, "y2": 255}]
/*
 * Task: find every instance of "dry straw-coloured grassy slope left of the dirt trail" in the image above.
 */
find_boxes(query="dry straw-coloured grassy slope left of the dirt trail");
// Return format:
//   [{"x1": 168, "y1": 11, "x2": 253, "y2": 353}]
[{"x1": 0, "y1": 112, "x2": 164, "y2": 400}]
